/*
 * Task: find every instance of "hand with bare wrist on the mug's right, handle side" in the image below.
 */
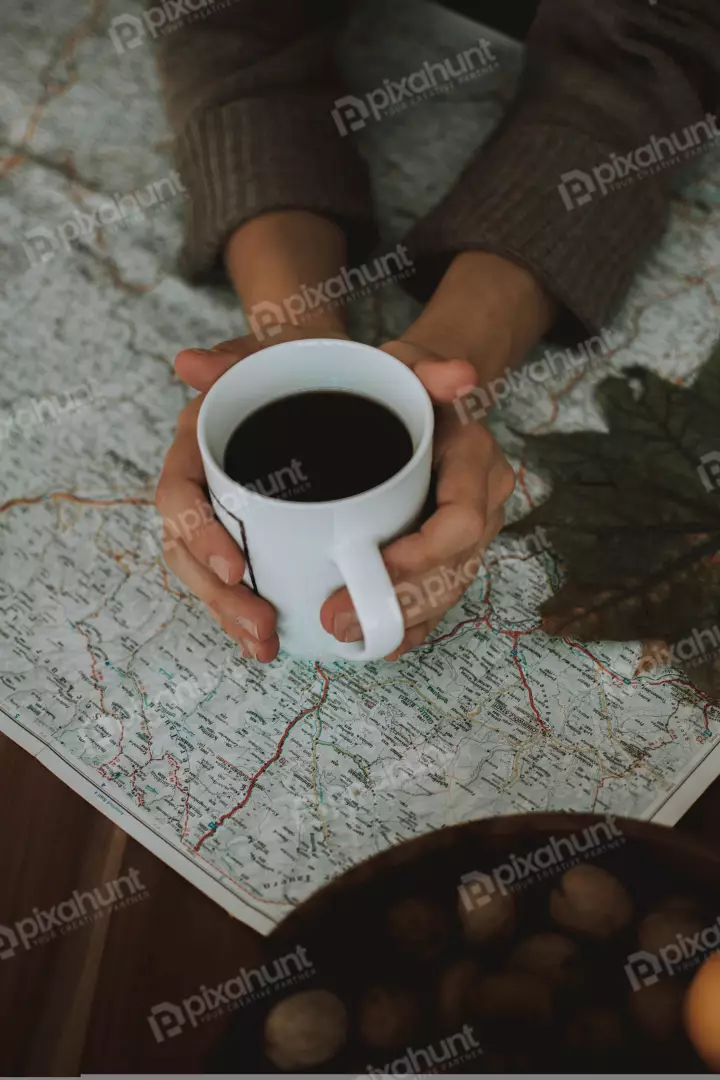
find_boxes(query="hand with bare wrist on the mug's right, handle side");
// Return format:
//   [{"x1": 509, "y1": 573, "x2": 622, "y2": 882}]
[{"x1": 321, "y1": 252, "x2": 557, "y2": 660}]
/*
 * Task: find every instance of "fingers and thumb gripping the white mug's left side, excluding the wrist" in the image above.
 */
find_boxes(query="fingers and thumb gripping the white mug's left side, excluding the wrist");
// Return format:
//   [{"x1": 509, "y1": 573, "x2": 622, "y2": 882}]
[{"x1": 155, "y1": 327, "x2": 345, "y2": 663}]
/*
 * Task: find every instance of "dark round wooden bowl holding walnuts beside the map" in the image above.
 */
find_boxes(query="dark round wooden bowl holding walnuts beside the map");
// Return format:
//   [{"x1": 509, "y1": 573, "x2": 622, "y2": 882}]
[{"x1": 216, "y1": 813, "x2": 720, "y2": 1075}]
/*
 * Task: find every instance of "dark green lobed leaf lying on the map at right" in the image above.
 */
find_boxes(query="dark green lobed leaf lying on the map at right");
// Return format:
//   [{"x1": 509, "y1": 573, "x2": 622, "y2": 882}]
[{"x1": 508, "y1": 347, "x2": 720, "y2": 698}]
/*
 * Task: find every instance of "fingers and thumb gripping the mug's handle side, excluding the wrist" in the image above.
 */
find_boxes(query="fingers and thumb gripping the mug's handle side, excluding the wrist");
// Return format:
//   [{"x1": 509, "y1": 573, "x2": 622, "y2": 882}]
[{"x1": 321, "y1": 340, "x2": 515, "y2": 660}]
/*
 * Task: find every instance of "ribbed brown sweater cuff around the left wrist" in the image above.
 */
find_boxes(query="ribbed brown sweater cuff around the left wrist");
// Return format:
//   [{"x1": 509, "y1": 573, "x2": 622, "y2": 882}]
[{"x1": 176, "y1": 93, "x2": 377, "y2": 280}]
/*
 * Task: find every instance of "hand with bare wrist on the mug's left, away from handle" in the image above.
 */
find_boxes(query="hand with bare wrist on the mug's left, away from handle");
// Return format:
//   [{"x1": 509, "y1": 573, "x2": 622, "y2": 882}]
[{"x1": 155, "y1": 203, "x2": 354, "y2": 663}]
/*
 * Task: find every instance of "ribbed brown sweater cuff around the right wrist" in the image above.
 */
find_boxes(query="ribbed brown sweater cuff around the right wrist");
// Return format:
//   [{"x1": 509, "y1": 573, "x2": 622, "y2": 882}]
[{"x1": 405, "y1": 120, "x2": 668, "y2": 341}]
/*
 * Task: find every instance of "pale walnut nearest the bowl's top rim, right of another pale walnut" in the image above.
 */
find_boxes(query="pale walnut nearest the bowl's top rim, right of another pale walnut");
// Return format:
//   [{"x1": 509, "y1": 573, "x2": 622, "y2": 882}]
[{"x1": 551, "y1": 866, "x2": 633, "y2": 939}]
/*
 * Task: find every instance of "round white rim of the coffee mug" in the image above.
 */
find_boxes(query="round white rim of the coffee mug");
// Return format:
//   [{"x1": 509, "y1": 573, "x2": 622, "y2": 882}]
[{"x1": 196, "y1": 338, "x2": 435, "y2": 510}]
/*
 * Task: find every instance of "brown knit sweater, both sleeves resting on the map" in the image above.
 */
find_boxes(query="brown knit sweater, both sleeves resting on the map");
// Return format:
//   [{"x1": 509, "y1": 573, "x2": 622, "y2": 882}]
[{"x1": 160, "y1": 0, "x2": 720, "y2": 333}]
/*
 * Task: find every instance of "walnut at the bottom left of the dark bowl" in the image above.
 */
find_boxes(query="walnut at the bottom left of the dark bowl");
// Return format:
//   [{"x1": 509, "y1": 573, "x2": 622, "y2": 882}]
[{"x1": 264, "y1": 990, "x2": 348, "y2": 1070}]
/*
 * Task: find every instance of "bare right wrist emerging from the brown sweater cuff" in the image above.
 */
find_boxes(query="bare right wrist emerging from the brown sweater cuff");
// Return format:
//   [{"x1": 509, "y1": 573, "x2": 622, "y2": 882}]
[{"x1": 403, "y1": 252, "x2": 558, "y2": 380}]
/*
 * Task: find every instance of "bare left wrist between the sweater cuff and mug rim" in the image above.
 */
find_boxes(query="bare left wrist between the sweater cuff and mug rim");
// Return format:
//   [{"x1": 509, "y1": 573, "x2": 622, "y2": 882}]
[{"x1": 226, "y1": 211, "x2": 348, "y2": 336}]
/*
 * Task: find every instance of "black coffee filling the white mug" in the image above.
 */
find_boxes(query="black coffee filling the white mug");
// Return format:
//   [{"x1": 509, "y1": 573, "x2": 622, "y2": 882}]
[{"x1": 225, "y1": 390, "x2": 413, "y2": 502}]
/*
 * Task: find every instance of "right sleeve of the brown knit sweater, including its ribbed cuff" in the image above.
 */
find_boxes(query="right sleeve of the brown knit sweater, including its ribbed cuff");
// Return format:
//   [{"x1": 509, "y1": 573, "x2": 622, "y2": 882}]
[{"x1": 406, "y1": 0, "x2": 720, "y2": 339}]
